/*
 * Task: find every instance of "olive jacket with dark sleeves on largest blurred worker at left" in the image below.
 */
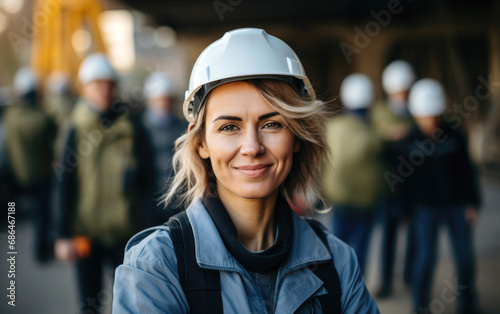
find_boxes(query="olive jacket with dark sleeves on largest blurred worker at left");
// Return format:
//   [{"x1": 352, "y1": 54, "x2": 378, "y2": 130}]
[{"x1": 57, "y1": 101, "x2": 141, "y2": 246}]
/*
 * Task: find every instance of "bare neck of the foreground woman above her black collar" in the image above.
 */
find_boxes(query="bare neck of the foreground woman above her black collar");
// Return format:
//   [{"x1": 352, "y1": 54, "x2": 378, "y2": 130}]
[{"x1": 219, "y1": 189, "x2": 278, "y2": 252}]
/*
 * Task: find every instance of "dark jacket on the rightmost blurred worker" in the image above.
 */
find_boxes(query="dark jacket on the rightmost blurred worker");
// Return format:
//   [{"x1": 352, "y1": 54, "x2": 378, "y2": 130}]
[{"x1": 400, "y1": 122, "x2": 480, "y2": 208}]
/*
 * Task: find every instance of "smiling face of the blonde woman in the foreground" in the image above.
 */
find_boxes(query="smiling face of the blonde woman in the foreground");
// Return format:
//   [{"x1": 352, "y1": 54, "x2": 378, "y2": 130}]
[{"x1": 198, "y1": 82, "x2": 300, "y2": 199}]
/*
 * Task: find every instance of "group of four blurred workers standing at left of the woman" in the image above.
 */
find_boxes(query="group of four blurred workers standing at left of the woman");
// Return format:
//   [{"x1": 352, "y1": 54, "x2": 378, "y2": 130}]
[{"x1": 0, "y1": 53, "x2": 187, "y2": 313}]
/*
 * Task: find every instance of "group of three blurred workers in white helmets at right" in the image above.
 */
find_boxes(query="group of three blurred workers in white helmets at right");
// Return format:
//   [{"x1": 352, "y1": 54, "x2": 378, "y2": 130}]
[{"x1": 321, "y1": 60, "x2": 480, "y2": 313}]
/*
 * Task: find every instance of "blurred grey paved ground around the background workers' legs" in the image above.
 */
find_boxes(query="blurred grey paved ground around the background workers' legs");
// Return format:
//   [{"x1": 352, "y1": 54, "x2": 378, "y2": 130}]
[{"x1": 0, "y1": 178, "x2": 500, "y2": 314}]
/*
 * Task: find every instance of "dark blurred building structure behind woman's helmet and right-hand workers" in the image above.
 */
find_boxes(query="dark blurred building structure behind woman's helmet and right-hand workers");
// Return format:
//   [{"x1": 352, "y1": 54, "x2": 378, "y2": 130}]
[{"x1": 116, "y1": 0, "x2": 500, "y2": 174}]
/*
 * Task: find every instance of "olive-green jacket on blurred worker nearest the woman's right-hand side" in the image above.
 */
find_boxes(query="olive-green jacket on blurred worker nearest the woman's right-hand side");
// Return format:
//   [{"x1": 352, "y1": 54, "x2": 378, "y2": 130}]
[{"x1": 321, "y1": 114, "x2": 384, "y2": 209}]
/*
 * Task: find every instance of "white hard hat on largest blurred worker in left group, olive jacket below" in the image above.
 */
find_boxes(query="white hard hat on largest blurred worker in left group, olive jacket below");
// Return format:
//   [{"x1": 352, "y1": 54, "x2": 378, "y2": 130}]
[{"x1": 78, "y1": 53, "x2": 118, "y2": 85}]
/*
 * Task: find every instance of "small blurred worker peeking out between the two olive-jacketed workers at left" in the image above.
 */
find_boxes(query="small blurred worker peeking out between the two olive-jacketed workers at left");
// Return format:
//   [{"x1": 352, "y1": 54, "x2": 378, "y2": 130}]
[{"x1": 44, "y1": 72, "x2": 78, "y2": 130}]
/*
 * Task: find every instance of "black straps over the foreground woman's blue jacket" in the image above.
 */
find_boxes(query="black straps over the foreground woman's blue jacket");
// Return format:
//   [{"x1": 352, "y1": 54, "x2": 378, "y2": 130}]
[{"x1": 165, "y1": 211, "x2": 342, "y2": 314}]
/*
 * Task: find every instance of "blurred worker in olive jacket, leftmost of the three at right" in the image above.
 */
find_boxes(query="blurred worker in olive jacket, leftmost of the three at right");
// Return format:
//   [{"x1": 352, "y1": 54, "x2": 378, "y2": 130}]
[{"x1": 322, "y1": 74, "x2": 383, "y2": 271}]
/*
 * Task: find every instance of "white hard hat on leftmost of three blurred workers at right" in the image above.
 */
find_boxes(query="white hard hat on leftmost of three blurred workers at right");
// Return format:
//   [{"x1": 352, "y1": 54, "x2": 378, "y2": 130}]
[{"x1": 340, "y1": 73, "x2": 373, "y2": 109}]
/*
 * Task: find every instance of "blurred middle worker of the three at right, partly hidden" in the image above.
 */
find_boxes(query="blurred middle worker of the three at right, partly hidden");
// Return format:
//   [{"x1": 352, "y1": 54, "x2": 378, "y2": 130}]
[{"x1": 372, "y1": 60, "x2": 415, "y2": 298}]
